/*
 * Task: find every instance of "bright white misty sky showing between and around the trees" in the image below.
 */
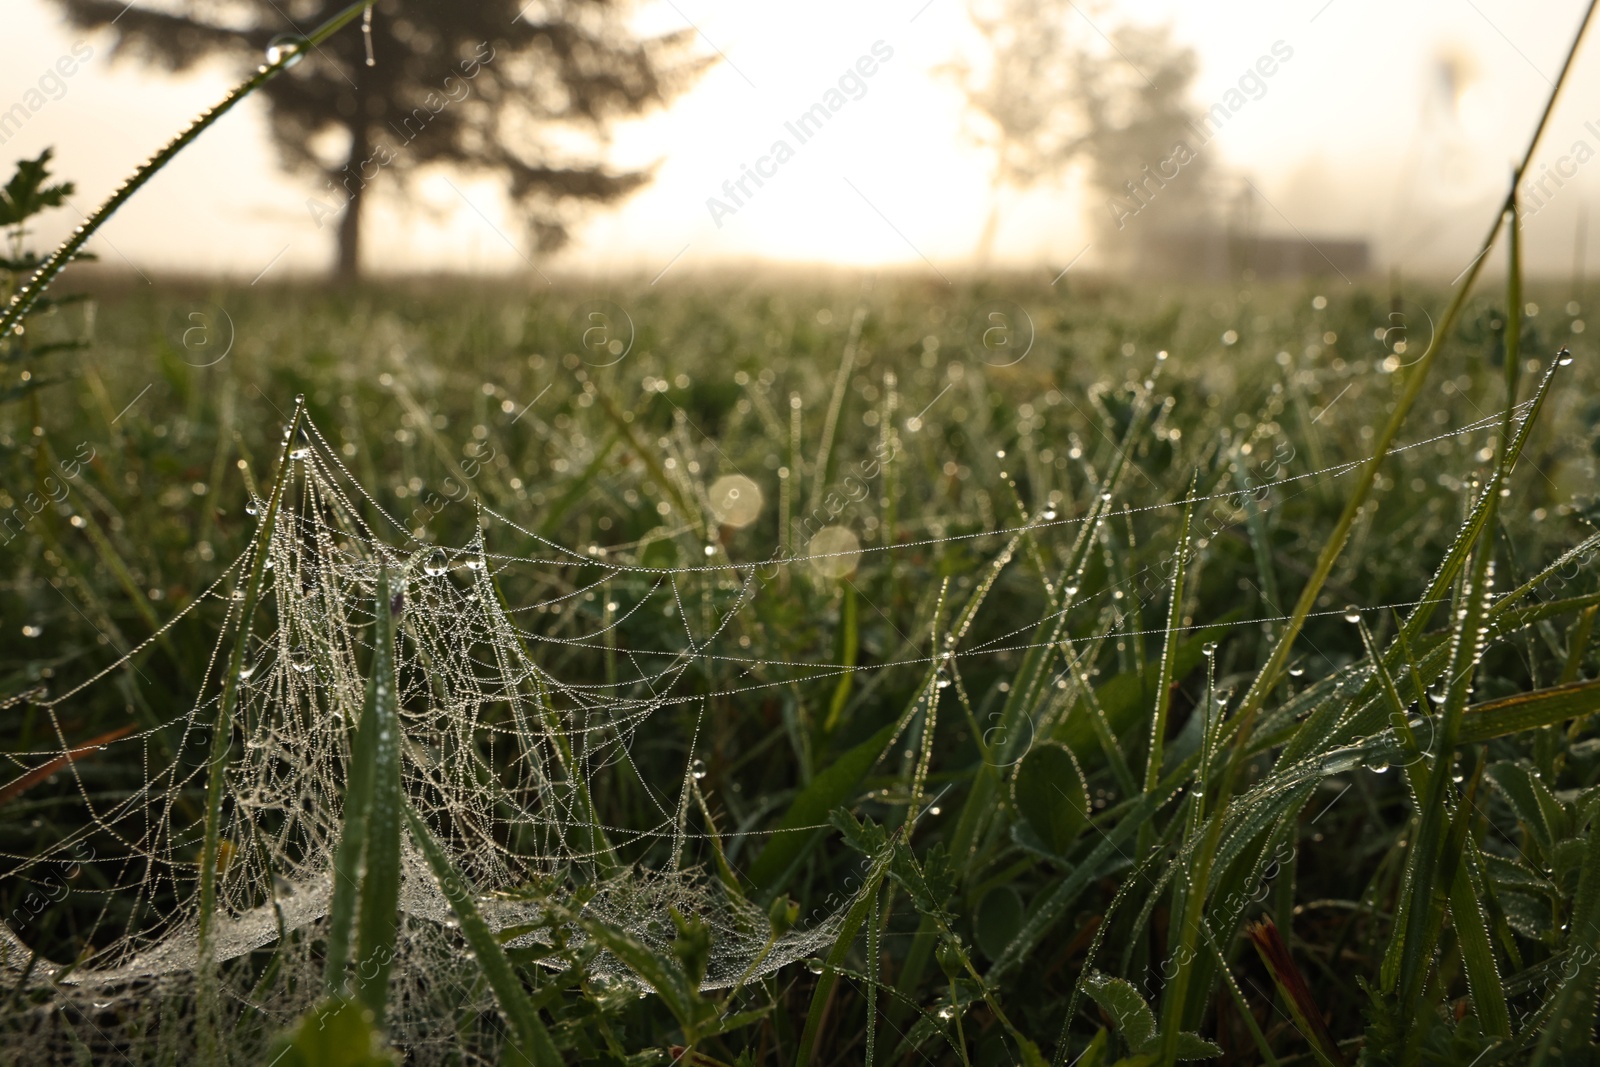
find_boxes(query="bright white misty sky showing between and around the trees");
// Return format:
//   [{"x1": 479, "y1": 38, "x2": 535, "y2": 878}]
[{"x1": 0, "y1": 0, "x2": 1600, "y2": 278}]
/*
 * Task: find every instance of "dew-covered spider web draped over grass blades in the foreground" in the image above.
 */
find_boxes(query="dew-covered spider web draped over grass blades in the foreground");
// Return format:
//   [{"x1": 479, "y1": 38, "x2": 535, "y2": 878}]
[{"x1": 0, "y1": 399, "x2": 1561, "y2": 1062}]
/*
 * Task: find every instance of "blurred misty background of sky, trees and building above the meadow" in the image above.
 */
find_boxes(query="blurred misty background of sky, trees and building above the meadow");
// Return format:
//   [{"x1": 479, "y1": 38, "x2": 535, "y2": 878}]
[{"x1": 0, "y1": 0, "x2": 1600, "y2": 282}]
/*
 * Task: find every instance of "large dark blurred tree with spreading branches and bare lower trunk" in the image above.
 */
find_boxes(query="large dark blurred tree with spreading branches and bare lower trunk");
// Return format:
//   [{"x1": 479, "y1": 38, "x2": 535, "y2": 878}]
[{"x1": 56, "y1": 0, "x2": 706, "y2": 277}]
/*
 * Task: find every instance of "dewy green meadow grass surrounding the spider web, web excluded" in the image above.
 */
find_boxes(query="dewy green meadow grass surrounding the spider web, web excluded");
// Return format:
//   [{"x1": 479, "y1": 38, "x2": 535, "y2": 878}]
[{"x1": 0, "y1": 260, "x2": 1600, "y2": 1064}]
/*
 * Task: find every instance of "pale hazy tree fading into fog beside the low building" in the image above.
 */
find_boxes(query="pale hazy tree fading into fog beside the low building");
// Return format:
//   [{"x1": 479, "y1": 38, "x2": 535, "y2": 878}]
[{"x1": 950, "y1": 0, "x2": 1205, "y2": 259}]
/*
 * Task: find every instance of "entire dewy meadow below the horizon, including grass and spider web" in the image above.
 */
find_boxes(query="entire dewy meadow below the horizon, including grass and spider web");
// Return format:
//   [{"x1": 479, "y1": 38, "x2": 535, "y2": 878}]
[{"x1": 0, "y1": 262, "x2": 1600, "y2": 1064}]
